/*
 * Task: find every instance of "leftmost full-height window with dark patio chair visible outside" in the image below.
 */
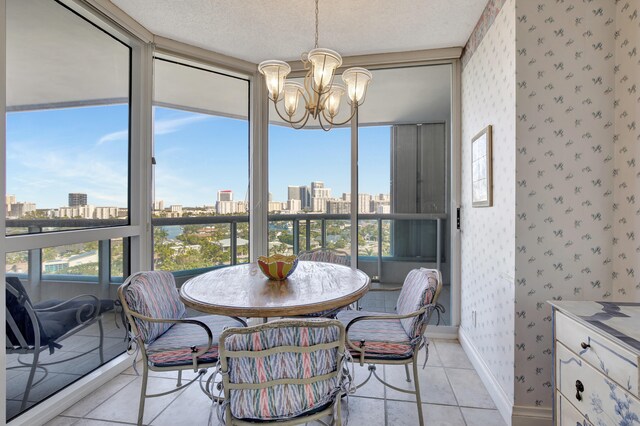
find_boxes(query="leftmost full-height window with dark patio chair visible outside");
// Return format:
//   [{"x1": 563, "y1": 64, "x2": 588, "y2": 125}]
[{"x1": 4, "y1": 0, "x2": 133, "y2": 419}]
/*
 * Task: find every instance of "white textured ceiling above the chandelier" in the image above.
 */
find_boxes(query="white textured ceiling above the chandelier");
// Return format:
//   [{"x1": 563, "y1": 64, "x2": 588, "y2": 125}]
[{"x1": 111, "y1": 0, "x2": 487, "y2": 63}]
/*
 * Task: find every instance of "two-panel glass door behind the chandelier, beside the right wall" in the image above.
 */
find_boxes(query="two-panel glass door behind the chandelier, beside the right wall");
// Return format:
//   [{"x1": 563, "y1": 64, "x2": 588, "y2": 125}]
[{"x1": 268, "y1": 64, "x2": 455, "y2": 325}]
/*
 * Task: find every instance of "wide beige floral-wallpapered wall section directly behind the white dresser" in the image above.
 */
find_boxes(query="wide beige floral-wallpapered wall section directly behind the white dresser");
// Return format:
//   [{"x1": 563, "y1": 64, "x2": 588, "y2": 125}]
[{"x1": 515, "y1": 0, "x2": 624, "y2": 407}]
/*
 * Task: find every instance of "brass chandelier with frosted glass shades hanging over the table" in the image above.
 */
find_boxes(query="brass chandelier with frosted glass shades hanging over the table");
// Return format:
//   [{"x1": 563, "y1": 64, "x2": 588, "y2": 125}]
[{"x1": 258, "y1": 0, "x2": 371, "y2": 131}]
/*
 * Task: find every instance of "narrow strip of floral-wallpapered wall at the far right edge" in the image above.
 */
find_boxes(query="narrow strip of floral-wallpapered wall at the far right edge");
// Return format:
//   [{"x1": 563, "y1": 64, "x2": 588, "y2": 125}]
[{"x1": 611, "y1": 0, "x2": 640, "y2": 301}]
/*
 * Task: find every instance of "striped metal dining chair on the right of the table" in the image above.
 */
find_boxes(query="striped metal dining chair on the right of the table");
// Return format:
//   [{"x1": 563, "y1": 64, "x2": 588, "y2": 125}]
[{"x1": 338, "y1": 268, "x2": 442, "y2": 425}]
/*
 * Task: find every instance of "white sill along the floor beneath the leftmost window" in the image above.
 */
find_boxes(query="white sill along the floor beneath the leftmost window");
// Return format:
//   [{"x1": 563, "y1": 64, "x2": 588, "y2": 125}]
[{"x1": 7, "y1": 353, "x2": 132, "y2": 426}]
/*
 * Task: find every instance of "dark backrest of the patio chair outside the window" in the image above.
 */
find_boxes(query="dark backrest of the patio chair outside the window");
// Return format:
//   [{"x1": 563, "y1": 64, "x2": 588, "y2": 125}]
[{"x1": 5, "y1": 277, "x2": 49, "y2": 350}]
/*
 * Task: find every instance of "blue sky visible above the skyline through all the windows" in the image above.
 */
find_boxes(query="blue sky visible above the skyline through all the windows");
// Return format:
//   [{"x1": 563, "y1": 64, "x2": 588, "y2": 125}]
[{"x1": 7, "y1": 105, "x2": 390, "y2": 208}]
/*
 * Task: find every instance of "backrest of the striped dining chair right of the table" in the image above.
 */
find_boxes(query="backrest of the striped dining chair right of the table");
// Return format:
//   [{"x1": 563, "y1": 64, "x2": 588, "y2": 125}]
[{"x1": 397, "y1": 268, "x2": 442, "y2": 337}]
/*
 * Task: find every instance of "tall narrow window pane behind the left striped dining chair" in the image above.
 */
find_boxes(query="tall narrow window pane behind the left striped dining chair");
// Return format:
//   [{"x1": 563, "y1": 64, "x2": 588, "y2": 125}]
[{"x1": 152, "y1": 57, "x2": 249, "y2": 276}]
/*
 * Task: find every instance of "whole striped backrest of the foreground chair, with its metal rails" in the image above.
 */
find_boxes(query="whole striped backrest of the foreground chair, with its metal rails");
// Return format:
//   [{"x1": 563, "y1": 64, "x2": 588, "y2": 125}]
[{"x1": 219, "y1": 319, "x2": 345, "y2": 420}]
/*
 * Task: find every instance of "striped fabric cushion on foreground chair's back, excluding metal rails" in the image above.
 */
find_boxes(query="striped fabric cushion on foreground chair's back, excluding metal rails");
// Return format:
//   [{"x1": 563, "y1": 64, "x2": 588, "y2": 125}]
[{"x1": 225, "y1": 326, "x2": 340, "y2": 420}]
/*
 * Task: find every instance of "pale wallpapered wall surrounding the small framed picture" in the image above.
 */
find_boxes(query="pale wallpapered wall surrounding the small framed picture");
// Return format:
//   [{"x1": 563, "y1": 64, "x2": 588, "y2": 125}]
[{"x1": 461, "y1": 0, "x2": 516, "y2": 401}]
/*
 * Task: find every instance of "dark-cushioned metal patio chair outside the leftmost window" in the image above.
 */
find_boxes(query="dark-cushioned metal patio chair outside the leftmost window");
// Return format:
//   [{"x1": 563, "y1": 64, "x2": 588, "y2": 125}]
[{"x1": 5, "y1": 276, "x2": 113, "y2": 410}]
